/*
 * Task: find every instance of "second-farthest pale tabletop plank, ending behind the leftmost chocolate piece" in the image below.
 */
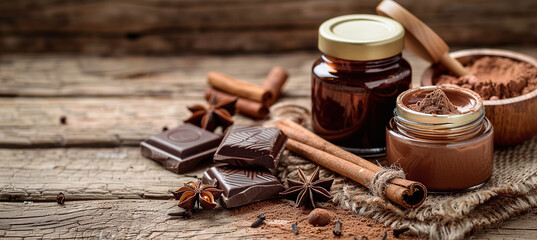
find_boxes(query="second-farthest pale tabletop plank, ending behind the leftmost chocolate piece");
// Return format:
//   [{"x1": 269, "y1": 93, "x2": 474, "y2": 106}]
[{"x1": 0, "y1": 96, "x2": 310, "y2": 148}]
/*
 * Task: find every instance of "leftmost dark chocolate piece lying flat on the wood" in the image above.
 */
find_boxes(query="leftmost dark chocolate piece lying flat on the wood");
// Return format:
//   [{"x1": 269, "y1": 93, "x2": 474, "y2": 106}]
[{"x1": 140, "y1": 123, "x2": 222, "y2": 173}]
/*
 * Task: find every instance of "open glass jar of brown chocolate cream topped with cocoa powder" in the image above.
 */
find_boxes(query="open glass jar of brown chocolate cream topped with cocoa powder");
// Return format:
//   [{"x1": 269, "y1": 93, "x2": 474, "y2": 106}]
[{"x1": 386, "y1": 87, "x2": 494, "y2": 192}]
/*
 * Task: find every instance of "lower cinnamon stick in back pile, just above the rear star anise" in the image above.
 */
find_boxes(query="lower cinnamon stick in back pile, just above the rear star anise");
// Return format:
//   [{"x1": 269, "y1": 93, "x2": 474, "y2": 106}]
[{"x1": 205, "y1": 88, "x2": 269, "y2": 119}]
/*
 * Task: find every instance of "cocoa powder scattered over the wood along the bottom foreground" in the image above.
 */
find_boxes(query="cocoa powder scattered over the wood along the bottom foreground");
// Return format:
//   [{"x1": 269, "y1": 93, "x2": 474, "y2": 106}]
[{"x1": 231, "y1": 199, "x2": 417, "y2": 239}]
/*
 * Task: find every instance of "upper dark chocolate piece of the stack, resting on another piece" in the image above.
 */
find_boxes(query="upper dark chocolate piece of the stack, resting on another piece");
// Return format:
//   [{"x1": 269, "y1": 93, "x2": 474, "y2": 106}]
[{"x1": 214, "y1": 126, "x2": 287, "y2": 169}]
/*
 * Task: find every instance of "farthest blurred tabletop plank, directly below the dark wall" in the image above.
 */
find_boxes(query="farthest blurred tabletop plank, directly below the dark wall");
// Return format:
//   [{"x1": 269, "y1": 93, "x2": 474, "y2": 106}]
[{"x1": 0, "y1": 52, "x2": 319, "y2": 99}]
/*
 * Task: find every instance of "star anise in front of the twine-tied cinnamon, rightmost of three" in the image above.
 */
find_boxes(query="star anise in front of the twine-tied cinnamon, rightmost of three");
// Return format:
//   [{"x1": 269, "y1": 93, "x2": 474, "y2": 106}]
[{"x1": 280, "y1": 167, "x2": 334, "y2": 208}]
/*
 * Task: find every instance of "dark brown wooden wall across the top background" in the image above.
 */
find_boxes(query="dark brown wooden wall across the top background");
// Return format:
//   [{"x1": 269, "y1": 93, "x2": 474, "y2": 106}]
[{"x1": 0, "y1": 0, "x2": 537, "y2": 55}]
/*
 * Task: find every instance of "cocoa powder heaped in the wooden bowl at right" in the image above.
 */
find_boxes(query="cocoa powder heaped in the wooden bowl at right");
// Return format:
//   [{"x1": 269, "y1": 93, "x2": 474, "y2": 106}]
[{"x1": 433, "y1": 56, "x2": 537, "y2": 100}]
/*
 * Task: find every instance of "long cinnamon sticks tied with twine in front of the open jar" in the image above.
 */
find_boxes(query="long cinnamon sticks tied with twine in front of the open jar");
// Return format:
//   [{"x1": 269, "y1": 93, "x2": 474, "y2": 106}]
[{"x1": 276, "y1": 119, "x2": 427, "y2": 208}]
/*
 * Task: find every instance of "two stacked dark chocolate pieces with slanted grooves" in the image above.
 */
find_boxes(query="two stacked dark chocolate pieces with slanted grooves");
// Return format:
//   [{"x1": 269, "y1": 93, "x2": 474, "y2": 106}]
[{"x1": 203, "y1": 126, "x2": 287, "y2": 208}]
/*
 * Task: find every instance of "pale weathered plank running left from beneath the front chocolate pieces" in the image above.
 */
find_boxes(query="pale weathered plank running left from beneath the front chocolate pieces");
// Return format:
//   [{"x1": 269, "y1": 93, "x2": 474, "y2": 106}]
[{"x1": 0, "y1": 147, "x2": 209, "y2": 201}]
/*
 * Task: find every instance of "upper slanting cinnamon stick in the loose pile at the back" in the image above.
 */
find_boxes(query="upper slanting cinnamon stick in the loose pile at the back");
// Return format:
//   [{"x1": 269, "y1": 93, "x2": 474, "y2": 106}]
[{"x1": 207, "y1": 72, "x2": 272, "y2": 106}]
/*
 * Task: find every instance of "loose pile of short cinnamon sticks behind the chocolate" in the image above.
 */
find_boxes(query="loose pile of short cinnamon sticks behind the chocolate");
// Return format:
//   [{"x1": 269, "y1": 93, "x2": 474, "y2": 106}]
[{"x1": 205, "y1": 67, "x2": 288, "y2": 119}]
